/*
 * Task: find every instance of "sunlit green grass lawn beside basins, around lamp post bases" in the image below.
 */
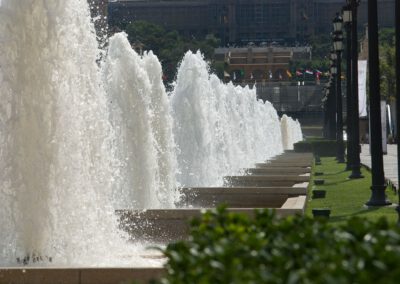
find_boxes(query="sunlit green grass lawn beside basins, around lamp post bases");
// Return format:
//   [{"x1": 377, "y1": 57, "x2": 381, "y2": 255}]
[{"x1": 306, "y1": 158, "x2": 398, "y2": 224}]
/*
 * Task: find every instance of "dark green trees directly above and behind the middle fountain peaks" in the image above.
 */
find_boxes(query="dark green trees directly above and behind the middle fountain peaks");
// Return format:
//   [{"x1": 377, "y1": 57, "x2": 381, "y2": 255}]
[{"x1": 125, "y1": 21, "x2": 220, "y2": 83}]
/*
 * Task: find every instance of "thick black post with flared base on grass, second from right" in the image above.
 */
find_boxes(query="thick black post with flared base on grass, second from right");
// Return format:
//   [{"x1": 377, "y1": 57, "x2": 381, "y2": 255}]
[{"x1": 366, "y1": 0, "x2": 391, "y2": 206}]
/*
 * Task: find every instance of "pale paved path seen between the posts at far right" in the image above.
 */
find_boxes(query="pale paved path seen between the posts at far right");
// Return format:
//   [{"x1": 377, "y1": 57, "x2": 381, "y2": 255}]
[{"x1": 360, "y1": 144, "x2": 399, "y2": 188}]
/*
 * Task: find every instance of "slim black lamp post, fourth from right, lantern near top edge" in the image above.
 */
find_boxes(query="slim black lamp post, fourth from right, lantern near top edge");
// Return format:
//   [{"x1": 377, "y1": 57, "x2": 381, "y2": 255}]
[{"x1": 343, "y1": 5, "x2": 354, "y2": 171}]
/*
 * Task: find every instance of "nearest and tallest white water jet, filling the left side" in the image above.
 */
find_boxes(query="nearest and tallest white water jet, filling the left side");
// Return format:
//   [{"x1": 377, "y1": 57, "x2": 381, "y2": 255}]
[{"x1": 0, "y1": 0, "x2": 159, "y2": 266}]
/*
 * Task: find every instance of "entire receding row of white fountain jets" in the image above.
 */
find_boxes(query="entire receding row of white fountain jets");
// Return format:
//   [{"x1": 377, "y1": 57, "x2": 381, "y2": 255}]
[{"x1": 0, "y1": 0, "x2": 302, "y2": 266}]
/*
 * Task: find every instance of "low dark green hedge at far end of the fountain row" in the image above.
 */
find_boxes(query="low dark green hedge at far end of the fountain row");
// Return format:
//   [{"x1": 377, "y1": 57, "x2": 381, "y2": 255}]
[{"x1": 294, "y1": 140, "x2": 346, "y2": 157}]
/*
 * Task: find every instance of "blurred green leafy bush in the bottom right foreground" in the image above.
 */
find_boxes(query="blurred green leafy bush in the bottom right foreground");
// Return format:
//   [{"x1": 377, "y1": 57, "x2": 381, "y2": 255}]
[{"x1": 162, "y1": 208, "x2": 400, "y2": 284}]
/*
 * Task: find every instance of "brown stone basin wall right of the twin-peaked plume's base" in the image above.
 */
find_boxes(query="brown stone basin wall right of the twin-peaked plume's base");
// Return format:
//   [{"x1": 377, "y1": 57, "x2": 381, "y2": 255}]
[{"x1": 177, "y1": 187, "x2": 307, "y2": 208}]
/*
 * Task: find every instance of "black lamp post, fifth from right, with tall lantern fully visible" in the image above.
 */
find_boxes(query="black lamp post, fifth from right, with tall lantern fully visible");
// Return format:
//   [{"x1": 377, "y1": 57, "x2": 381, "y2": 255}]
[{"x1": 333, "y1": 14, "x2": 344, "y2": 163}]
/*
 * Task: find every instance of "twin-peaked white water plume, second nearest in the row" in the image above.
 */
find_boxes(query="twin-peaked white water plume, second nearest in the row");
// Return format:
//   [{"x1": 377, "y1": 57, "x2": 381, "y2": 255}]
[{"x1": 104, "y1": 33, "x2": 176, "y2": 209}]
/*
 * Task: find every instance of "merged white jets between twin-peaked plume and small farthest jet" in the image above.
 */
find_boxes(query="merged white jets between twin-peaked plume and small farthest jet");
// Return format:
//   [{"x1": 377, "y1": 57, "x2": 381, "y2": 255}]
[{"x1": 171, "y1": 51, "x2": 283, "y2": 186}]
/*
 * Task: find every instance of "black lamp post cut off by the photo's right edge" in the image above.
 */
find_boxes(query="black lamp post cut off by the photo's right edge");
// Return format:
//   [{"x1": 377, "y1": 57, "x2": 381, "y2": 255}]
[{"x1": 394, "y1": 1, "x2": 400, "y2": 224}]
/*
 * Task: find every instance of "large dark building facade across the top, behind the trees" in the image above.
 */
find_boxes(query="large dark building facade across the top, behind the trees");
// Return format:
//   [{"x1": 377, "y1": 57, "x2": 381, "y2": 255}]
[{"x1": 108, "y1": 0, "x2": 395, "y2": 45}]
